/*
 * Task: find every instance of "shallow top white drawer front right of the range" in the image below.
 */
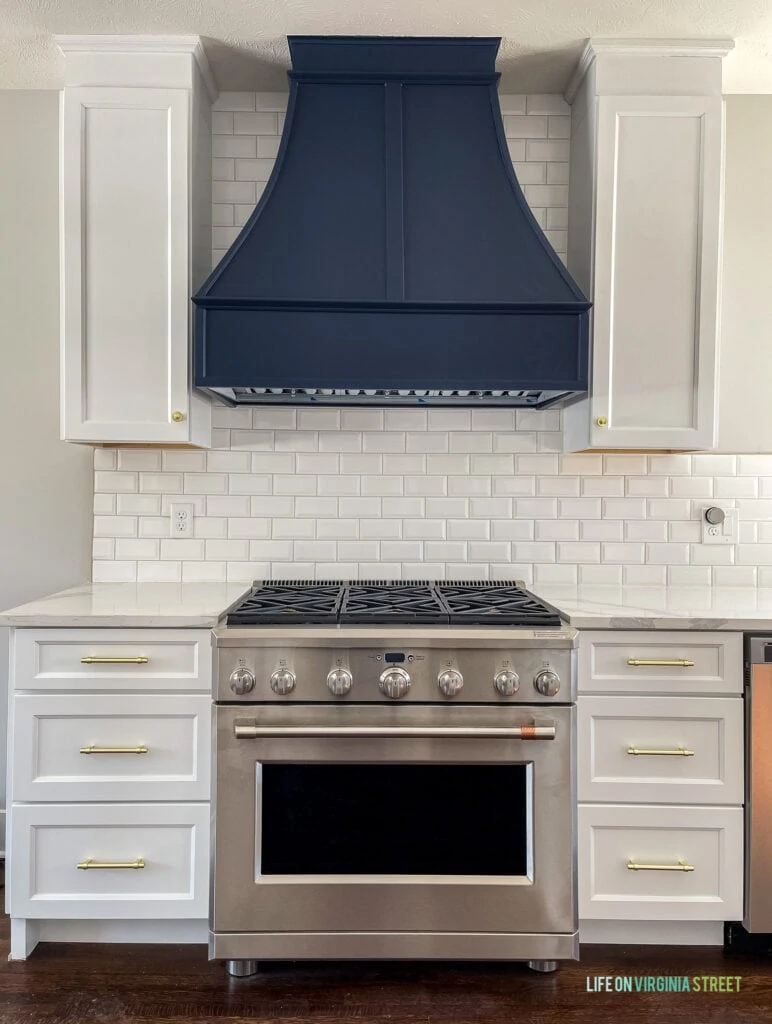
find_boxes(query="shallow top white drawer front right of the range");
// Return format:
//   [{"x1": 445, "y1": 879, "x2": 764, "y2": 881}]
[{"x1": 578, "y1": 630, "x2": 742, "y2": 695}]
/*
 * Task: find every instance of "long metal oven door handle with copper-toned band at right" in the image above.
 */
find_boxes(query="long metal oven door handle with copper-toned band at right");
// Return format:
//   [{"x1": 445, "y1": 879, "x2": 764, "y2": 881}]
[{"x1": 233, "y1": 719, "x2": 555, "y2": 739}]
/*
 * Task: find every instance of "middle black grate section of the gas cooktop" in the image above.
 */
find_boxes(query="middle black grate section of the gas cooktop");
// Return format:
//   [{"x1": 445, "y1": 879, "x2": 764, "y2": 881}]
[{"x1": 339, "y1": 580, "x2": 447, "y2": 626}]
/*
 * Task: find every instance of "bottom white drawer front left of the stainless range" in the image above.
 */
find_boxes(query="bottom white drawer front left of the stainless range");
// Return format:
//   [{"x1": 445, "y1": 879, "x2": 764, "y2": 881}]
[{"x1": 9, "y1": 804, "x2": 209, "y2": 919}]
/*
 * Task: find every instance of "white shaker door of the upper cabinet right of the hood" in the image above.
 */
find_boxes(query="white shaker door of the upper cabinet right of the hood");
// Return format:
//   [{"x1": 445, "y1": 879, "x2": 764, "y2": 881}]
[{"x1": 589, "y1": 95, "x2": 724, "y2": 449}]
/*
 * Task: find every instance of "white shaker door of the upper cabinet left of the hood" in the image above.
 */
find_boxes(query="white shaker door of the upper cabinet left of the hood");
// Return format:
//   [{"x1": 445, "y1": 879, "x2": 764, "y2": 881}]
[{"x1": 60, "y1": 88, "x2": 198, "y2": 443}]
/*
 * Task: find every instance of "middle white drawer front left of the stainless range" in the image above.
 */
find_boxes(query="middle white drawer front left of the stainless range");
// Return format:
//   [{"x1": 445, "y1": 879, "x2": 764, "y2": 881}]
[{"x1": 12, "y1": 693, "x2": 211, "y2": 802}]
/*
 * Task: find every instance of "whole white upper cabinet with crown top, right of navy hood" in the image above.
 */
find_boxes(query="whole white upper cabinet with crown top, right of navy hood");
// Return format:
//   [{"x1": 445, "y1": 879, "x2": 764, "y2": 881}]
[{"x1": 564, "y1": 44, "x2": 726, "y2": 451}]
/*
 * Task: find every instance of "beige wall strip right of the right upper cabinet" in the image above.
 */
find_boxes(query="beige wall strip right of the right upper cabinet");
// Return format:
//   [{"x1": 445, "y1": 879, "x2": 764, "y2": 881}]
[{"x1": 719, "y1": 96, "x2": 772, "y2": 452}]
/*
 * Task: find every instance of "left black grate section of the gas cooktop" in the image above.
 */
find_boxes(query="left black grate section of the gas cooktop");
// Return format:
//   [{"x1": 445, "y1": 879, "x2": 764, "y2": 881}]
[{"x1": 227, "y1": 580, "x2": 344, "y2": 626}]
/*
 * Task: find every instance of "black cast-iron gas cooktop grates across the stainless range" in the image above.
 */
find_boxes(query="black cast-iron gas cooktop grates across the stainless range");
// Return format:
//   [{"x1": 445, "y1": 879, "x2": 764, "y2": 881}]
[{"x1": 227, "y1": 580, "x2": 561, "y2": 628}]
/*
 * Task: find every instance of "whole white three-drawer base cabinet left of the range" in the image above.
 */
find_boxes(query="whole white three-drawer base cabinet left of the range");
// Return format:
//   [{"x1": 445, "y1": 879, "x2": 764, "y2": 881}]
[{"x1": 6, "y1": 629, "x2": 212, "y2": 959}]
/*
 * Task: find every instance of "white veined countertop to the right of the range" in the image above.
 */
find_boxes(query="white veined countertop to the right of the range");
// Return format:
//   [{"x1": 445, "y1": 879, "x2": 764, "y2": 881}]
[{"x1": 529, "y1": 585, "x2": 772, "y2": 631}]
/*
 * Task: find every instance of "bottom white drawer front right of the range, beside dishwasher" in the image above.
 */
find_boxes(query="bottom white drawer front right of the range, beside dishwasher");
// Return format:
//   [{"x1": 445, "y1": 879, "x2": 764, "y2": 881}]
[{"x1": 578, "y1": 804, "x2": 742, "y2": 921}]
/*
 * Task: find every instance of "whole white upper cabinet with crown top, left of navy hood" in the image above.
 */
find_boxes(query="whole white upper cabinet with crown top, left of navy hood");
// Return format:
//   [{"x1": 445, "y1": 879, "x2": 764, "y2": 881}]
[{"x1": 59, "y1": 37, "x2": 211, "y2": 446}]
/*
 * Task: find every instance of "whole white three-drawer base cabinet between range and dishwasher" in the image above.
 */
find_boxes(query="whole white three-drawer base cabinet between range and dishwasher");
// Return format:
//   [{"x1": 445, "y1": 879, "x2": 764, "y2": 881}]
[{"x1": 577, "y1": 630, "x2": 744, "y2": 942}]
